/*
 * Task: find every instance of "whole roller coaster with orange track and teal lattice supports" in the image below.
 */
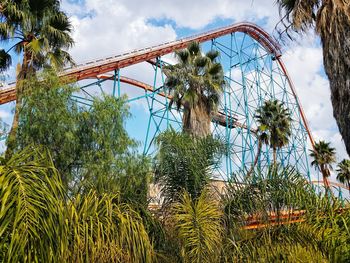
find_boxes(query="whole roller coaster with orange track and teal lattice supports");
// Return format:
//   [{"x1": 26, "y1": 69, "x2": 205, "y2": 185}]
[{"x1": 0, "y1": 23, "x2": 348, "y2": 200}]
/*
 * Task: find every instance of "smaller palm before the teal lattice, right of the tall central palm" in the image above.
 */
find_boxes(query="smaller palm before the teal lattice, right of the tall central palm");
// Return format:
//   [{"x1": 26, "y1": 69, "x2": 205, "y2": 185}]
[{"x1": 253, "y1": 99, "x2": 292, "y2": 168}]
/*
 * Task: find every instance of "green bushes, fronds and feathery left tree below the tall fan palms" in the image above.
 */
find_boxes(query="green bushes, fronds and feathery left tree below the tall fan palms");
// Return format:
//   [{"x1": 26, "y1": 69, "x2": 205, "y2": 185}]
[{"x1": 0, "y1": 71, "x2": 350, "y2": 262}]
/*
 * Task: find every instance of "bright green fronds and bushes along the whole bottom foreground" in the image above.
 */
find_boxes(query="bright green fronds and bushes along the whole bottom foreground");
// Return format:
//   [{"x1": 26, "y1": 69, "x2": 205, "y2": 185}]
[{"x1": 0, "y1": 145, "x2": 350, "y2": 262}]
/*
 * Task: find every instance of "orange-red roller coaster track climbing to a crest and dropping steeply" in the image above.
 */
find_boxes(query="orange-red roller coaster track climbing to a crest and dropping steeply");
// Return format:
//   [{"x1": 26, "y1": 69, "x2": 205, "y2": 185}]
[{"x1": 0, "y1": 22, "x2": 314, "y2": 139}]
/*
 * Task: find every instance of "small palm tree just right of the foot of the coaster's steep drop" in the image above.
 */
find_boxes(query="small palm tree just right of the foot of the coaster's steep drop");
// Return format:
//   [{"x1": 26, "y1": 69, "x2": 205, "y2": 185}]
[{"x1": 310, "y1": 140, "x2": 336, "y2": 194}]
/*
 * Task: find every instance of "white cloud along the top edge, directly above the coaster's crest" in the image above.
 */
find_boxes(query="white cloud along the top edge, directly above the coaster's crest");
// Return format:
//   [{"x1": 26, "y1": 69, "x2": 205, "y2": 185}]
[{"x1": 108, "y1": 0, "x2": 278, "y2": 29}]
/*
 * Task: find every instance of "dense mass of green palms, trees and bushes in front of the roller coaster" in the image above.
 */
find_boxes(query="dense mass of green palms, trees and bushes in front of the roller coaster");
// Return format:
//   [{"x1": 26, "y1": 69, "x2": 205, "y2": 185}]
[{"x1": 0, "y1": 0, "x2": 350, "y2": 262}]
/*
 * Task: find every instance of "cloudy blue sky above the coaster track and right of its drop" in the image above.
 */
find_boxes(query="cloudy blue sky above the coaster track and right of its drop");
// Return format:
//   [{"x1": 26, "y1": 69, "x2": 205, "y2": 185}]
[{"x1": 0, "y1": 0, "x2": 347, "y2": 183}]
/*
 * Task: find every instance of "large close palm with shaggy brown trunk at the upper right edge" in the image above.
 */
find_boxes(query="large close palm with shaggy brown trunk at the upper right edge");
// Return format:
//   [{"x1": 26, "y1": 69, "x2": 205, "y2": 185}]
[{"x1": 277, "y1": 0, "x2": 350, "y2": 157}]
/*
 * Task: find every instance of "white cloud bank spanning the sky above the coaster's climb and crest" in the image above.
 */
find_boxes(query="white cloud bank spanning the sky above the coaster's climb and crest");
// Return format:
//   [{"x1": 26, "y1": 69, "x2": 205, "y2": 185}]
[{"x1": 62, "y1": 0, "x2": 278, "y2": 62}]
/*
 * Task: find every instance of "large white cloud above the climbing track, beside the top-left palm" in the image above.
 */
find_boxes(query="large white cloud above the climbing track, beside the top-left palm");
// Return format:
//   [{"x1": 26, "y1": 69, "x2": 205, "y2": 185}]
[{"x1": 64, "y1": 0, "x2": 176, "y2": 63}]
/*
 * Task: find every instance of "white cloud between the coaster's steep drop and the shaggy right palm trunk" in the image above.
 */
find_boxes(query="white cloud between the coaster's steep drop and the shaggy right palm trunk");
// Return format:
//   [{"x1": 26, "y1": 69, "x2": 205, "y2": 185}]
[{"x1": 282, "y1": 38, "x2": 348, "y2": 161}]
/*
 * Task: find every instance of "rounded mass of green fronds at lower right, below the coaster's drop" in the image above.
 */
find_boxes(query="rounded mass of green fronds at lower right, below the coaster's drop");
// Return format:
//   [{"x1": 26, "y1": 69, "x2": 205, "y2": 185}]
[{"x1": 223, "y1": 166, "x2": 350, "y2": 262}]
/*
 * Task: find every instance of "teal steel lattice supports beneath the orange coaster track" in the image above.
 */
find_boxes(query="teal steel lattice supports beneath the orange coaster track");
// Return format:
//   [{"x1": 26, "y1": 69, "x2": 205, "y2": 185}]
[{"x1": 75, "y1": 32, "x2": 310, "y2": 182}]
